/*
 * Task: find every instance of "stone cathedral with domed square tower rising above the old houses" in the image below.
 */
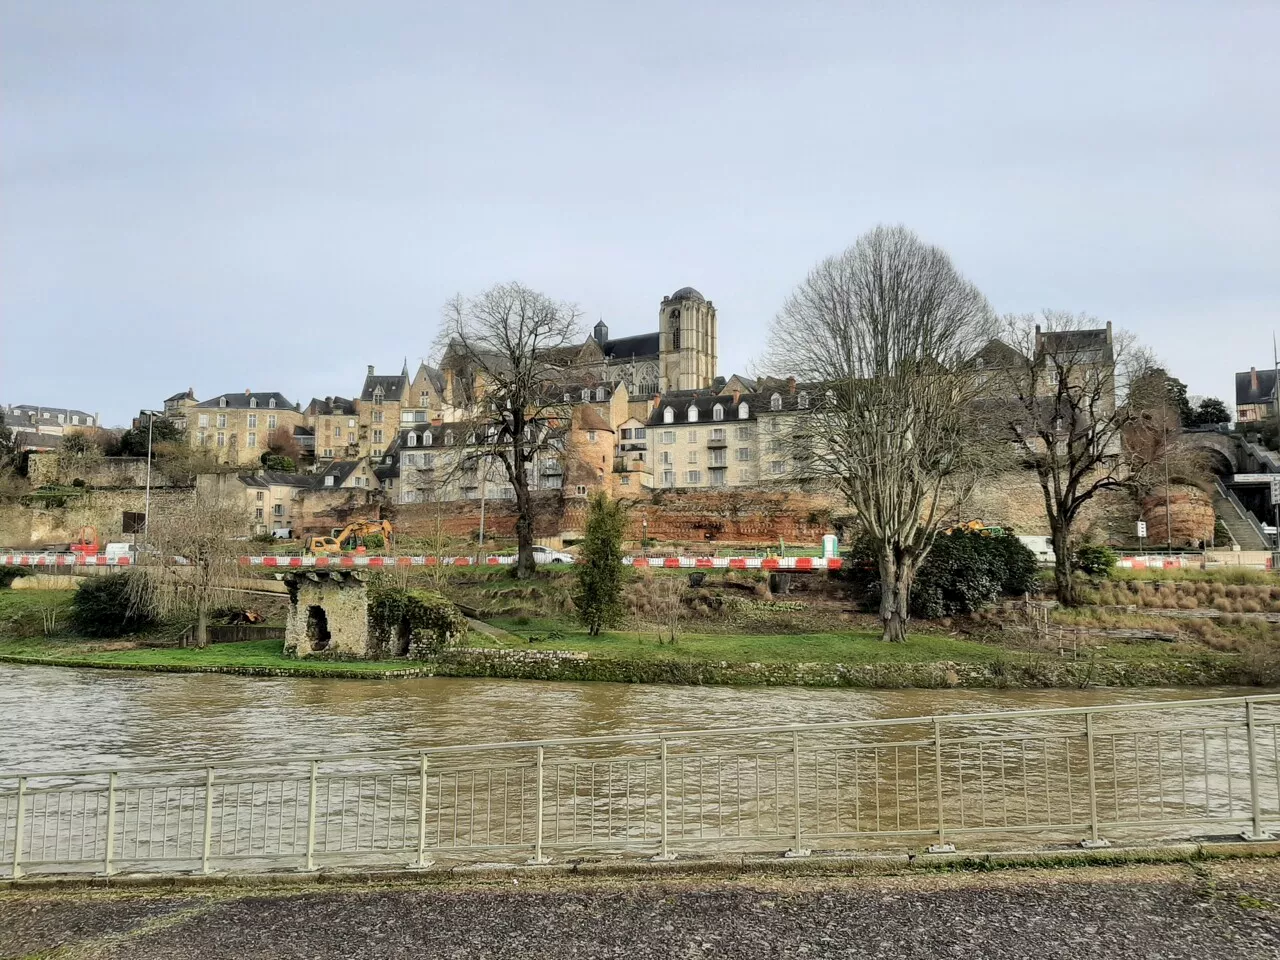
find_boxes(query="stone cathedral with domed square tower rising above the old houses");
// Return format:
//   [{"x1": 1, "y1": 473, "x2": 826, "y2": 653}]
[{"x1": 582, "y1": 287, "x2": 718, "y2": 398}]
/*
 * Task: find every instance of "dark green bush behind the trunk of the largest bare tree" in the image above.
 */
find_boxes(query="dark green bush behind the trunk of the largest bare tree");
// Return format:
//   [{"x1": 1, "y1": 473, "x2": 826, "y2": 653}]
[{"x1": 849, "y1": 531, "x2": 1037, "y2": 620}]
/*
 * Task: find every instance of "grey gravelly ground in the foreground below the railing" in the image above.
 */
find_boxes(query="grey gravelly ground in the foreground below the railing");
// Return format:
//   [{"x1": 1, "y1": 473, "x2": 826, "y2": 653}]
[{"x1": 0, "y1": 860, "x2": 1280, "y2": 960}]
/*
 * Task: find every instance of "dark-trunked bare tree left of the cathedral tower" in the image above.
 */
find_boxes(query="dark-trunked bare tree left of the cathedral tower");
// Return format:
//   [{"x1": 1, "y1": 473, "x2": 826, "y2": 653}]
[{"x1": 442, "y1": 283, "x2": 585, "y2": 579}]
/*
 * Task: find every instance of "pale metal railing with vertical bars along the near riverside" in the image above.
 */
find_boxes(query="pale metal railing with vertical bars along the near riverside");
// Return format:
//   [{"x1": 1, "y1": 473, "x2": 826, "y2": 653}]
[{"x1": 0, "y1": 695, "x2": 1280, "y2": 877}]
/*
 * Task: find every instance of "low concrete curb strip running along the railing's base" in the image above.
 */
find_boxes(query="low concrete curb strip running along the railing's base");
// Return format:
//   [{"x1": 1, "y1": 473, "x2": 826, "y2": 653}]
[{"x1": 0, "y1": 838, "x2": 1280, "y2": 893}]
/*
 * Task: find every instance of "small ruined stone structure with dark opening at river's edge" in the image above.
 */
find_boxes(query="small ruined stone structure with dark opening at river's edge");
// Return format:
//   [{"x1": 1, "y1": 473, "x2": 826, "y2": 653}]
[{"x1": 284, "y1": 570, "x2": 372, "y2": 658}]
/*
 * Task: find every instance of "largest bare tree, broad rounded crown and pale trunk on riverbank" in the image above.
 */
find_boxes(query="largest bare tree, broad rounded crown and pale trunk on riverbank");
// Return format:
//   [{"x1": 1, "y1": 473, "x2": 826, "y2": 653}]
[{"x1": 772, "y1": 227, "x2": 995, "y2": 641}]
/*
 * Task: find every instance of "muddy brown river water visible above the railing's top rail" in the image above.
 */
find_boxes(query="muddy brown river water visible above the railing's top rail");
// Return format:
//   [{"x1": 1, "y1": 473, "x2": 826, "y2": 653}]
[{"x1": 0, "y1": 664, "x2": 1262, "y2": 771}]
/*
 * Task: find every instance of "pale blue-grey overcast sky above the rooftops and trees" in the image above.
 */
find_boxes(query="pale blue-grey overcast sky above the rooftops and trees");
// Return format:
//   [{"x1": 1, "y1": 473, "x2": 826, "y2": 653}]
[{"x1": 0, "y1": 0, "x2": 1280, "y2": 424}]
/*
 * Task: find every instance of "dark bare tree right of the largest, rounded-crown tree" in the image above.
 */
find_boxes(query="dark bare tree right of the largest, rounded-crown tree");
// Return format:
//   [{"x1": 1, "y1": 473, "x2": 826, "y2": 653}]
[{"x1": 984, "y1": 311, "x2": 1178, "y2": 605}]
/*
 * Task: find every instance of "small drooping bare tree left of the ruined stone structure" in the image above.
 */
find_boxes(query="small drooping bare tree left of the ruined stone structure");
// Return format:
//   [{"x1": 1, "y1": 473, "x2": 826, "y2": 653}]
[{"x1": 129, "y1": 486, "x2": 246, "y2": 648}]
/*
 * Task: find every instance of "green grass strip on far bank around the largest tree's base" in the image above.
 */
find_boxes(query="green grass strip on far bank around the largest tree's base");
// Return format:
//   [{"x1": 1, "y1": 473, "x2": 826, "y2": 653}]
[{"x1": 483, "y1": 617, "x2": 1018, "y2": 664}]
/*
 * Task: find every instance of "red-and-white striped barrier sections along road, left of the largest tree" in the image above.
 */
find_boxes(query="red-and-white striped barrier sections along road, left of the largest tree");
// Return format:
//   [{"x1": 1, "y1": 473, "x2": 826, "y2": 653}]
[{"x1": 0, "y1": 553, "x2": 842, "y2": 573}]
